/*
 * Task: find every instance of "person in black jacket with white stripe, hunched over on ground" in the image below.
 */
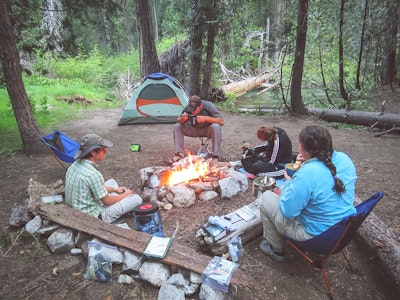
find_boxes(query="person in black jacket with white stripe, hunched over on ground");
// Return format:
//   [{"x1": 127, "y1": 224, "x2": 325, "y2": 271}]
[{"x1": 241, "y1": 126, "x2": 292, "y2": 179}]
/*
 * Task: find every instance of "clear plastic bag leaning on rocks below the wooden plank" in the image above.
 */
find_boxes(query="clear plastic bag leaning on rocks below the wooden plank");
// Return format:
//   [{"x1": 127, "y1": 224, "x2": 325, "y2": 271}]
[{"x1": 83, "y1": 241, "x2": 119, "y2": 282}]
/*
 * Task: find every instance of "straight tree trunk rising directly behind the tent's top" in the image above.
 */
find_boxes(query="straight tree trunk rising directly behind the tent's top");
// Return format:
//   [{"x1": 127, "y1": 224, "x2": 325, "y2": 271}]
[{"x1": 136, "y1": 0, "x2": 160, "y2": 78}]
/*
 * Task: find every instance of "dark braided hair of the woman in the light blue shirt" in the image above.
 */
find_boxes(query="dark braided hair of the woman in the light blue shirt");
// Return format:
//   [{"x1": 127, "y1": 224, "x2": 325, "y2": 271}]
[{"x1": 299, "y1": 126, "x2": 346, "y2": 193}]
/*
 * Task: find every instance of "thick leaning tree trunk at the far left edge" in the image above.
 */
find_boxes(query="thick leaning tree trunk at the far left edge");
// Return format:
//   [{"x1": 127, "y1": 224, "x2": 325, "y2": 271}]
[{"x1": 0, "y1": 1, "x2": 46, "y2": 155}]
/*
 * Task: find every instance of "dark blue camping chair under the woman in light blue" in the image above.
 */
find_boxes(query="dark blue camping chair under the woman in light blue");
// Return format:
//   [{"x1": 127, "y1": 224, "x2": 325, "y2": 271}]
[{"x1": 284, "y1": 192, "x2": 383, "y2": 299}]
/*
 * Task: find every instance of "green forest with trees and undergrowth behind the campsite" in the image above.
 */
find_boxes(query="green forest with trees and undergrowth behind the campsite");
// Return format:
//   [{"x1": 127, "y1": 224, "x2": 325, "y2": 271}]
[{"x1": 0, "y1": 0, "x2": 400, "y2": 154}]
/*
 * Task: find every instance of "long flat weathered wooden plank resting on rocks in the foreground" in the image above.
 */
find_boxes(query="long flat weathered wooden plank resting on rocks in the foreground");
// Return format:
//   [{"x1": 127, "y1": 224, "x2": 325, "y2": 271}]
[{"x1": 35, "y1": 203, "x2": 256, "y2": 287}]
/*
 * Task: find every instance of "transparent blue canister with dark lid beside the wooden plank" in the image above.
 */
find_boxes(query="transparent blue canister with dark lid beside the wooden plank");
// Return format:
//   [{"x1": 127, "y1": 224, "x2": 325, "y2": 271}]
[{"x1": 133, "y1": 203, "x2": 164, "y2": 237}]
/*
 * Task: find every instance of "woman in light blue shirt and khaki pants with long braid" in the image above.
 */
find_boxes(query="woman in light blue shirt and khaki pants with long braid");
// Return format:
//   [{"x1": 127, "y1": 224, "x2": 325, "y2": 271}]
[{"x1": 260, "y1": 126, "x2": 357, "y2": 261}]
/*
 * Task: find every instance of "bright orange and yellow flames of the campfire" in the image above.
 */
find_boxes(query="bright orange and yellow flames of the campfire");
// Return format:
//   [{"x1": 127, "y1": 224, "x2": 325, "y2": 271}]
[{"x1": 167, "y1": 155, "x2": 214, "y2": 186}]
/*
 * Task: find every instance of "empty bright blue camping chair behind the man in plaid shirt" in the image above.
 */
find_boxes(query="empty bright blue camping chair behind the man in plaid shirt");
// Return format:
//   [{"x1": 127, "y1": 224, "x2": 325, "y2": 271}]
[{"x1": 40, "y1": 130, "x2": 80, "y2": 169}]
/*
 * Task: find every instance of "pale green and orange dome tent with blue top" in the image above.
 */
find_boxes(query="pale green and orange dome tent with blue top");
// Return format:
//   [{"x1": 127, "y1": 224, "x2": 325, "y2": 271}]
[{"x1": 118, "y1": 73, "x2": 189, "y2": 125}]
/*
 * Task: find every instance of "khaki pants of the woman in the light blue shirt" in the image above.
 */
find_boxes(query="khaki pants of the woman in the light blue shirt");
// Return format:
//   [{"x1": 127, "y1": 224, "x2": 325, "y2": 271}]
[{"x1": 260, "y1": 191, "x2": 313, "y2": 249}]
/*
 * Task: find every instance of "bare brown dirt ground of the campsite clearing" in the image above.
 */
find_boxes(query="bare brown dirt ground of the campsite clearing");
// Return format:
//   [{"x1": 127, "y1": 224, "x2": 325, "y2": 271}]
[{"x1": 0, "y1": 89, "x2": 400, "y2": 300}]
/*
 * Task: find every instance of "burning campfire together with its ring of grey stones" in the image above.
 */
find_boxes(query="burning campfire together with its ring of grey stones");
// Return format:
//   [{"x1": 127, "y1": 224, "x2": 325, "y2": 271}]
[{"x1": 140, "y1": 155, "x2": 248, "y2": 209}]
